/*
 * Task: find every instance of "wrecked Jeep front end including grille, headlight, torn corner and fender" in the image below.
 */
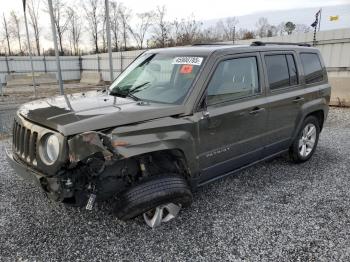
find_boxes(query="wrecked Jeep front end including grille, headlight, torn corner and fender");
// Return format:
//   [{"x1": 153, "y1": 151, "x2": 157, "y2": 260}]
[{"x1": 7, "y1": 116, "x2": 190, "y2": 209}]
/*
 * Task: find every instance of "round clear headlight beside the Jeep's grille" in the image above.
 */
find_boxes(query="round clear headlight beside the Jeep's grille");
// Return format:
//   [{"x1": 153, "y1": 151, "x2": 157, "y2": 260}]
[{"x1": 41, "y1": 134, "x2": 60, "y2": 165}]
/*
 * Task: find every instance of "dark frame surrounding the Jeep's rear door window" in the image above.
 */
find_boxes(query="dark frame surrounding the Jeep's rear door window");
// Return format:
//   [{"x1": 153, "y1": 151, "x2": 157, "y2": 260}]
[{"x1": 261, "y1": 50, "x2": 302, "y2": 94}]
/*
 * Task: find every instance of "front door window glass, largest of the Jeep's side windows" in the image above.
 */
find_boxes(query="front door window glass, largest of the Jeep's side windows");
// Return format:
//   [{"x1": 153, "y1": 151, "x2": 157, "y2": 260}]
[{"x1": 207, "y1": 57, "x2": 260, "y2": 105}]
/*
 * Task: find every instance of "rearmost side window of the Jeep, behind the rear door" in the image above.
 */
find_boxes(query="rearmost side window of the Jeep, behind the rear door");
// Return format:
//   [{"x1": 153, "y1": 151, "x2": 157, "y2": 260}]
[{"x1": 300, "y1": 53, "x2": 323, "y2": 84}]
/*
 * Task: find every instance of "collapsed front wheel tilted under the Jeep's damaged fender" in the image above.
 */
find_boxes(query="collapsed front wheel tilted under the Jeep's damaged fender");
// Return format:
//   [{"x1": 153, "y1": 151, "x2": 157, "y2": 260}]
[{"x1": 114, "y1": 174, "x2": 192, "y2": 227}]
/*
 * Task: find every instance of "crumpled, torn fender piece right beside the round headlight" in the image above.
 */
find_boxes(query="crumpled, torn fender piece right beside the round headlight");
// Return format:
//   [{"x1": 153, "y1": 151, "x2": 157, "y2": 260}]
[{"x1": 68, "y1": 131, "x2": 114, "y2": 163}]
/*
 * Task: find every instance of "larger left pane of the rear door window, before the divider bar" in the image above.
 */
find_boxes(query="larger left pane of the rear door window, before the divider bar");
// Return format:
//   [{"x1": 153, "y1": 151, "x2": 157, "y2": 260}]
[{"x1": 265, "y1": 55, "x2": 290, "y2": 90}]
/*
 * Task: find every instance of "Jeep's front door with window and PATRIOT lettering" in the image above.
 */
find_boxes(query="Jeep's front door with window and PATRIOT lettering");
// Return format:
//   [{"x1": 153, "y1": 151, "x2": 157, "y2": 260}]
[{"x1": 198, "y1": 53, "x2": 268, "y2": 183}]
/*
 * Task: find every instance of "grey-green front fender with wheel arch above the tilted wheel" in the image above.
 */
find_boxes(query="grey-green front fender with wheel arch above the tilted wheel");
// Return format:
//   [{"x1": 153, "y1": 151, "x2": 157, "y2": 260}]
[{"x1": 111, "y1": 117, "x2": 198, "y2": 175}]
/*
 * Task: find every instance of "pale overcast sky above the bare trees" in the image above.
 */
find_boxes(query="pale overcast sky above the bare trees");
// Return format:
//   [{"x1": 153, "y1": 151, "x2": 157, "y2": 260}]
[{"x1": 0, "y1": 0, "x2": 350, "y2": 49}]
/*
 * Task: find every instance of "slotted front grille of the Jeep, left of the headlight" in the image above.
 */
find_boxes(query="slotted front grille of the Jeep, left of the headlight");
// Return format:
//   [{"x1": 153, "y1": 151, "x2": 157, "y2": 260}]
[{"x1": 13, "y1": 121, "x2": 38, "y2": 165}]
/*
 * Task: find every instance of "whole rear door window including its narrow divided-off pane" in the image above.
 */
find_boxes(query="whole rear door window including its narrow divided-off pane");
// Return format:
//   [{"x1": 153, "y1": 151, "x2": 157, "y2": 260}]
[{"x1": 265, "y1": 54, "x2": 298, "y2": 90}]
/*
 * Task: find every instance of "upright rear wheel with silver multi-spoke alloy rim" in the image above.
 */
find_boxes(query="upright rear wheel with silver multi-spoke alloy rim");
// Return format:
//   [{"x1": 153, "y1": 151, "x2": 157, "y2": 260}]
[{"x1": 289, "y1": 116, "x2": 320, "y2": 163}]
